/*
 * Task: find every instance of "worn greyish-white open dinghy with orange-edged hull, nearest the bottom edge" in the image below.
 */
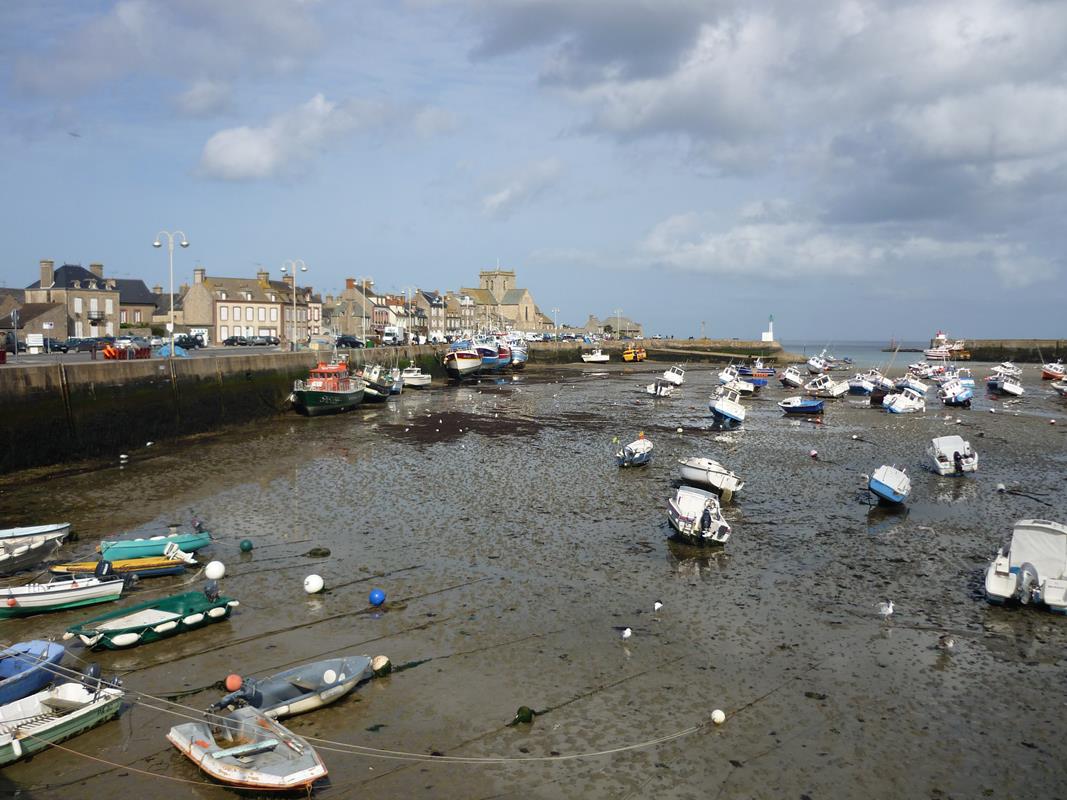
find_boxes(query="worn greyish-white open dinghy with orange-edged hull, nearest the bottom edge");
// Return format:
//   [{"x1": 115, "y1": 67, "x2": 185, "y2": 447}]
[{"x1": 166, "y1": 706, "x2": 327, "y2": 791}]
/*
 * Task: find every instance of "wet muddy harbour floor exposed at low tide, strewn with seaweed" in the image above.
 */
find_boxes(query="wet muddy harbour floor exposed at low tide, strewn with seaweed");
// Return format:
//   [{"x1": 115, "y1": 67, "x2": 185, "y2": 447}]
[{"x1": 0, "y1": 365, "x2": 1067, "y2": 799}]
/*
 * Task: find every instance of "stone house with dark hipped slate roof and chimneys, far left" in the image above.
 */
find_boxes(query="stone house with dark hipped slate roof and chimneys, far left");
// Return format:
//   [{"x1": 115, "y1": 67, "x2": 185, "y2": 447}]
[{"x1": 26, "y1": 260, "x2": 120, "y2": 339}]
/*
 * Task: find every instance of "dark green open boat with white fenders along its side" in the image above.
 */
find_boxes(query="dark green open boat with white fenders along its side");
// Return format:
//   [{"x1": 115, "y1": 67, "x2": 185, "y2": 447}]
[{"x1": 63, "y1": 592, "x2": 239, "y2": 650}]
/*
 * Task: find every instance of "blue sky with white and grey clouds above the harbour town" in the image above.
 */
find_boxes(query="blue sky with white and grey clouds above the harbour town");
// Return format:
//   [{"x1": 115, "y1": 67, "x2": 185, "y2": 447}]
[{"x1": 0, "y1": 0, "x2": 1067, "y2": 340}]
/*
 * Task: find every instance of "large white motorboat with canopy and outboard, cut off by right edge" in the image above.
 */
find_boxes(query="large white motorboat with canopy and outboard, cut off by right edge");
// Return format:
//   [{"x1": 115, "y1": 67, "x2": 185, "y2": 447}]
[{"x1": 986, "y1": 519, "x2": 1067, "y2": 613}]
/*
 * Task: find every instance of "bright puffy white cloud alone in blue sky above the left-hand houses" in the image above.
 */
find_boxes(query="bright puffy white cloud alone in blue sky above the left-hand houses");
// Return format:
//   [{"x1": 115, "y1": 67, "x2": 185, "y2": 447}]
[{"x1": 200, "y1": 94, "x2": 440, "y2": 180}]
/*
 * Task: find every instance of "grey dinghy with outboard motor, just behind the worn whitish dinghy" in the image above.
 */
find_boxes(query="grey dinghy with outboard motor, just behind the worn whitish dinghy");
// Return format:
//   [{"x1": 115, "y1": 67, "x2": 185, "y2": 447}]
[{"x1": 208, "y1": 656, "x2": 391, "y2": 719}]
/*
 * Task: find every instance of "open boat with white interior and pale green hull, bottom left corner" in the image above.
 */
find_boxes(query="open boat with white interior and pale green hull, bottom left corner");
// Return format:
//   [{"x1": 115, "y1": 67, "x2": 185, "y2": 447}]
[{"x1": 0, "y1": 675, "x2": 123, "y2": 766}]
